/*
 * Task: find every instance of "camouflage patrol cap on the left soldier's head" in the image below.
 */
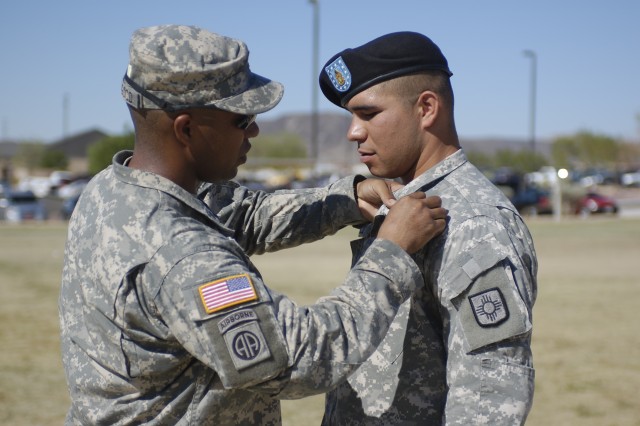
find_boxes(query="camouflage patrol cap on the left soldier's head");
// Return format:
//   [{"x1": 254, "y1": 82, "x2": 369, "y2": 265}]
[{"x1": 122, "y1": 25, "x2": 284, "y2": 114}]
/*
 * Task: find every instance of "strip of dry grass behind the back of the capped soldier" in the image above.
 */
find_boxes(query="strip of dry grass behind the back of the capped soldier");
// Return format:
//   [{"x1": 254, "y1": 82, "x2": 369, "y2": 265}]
[{"x1": 0, "y1": 225, "x2": 69, "y2": 426}]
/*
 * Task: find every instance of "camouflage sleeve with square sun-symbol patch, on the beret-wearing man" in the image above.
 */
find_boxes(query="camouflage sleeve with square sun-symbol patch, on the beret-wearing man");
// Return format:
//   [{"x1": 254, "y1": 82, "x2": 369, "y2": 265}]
[{"x1": 438, "y1": 223, "x2": 535, "y2": 425}]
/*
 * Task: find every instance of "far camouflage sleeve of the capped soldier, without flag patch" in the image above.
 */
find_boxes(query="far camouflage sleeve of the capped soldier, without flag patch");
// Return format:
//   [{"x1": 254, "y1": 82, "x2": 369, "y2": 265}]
[{"x1": 203, "y1": 176, "x2": 364, "y2": 255}]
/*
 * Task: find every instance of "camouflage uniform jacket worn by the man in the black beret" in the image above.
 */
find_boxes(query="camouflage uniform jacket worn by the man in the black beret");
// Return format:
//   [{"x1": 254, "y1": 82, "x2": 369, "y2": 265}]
[{"x1": 324, "y1": 150, "x2": 537, "y2": 426}]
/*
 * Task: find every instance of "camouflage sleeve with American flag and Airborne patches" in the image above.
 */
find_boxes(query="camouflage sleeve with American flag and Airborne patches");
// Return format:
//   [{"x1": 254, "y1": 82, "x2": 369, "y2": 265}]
[{"x1": 155, "y1": 236, "x2": 423, "y2": 398}]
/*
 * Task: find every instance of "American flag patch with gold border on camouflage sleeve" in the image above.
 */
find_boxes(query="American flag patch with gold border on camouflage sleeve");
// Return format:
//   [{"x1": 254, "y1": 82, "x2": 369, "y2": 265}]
[{"x1": 198, "y1": 274, "x2": 258, "y2": 314}]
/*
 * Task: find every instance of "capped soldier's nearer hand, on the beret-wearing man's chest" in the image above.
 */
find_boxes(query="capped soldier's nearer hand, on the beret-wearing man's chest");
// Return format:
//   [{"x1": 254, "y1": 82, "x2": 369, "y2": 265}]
[{"x1": 378, "y1": 192, "x2": 447, "y2": 254}]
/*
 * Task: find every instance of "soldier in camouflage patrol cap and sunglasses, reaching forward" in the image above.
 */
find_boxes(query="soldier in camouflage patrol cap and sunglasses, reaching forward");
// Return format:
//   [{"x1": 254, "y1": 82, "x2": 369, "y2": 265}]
[{"x1": 59, "y1": 25, "x2": 446, "y2": 425}]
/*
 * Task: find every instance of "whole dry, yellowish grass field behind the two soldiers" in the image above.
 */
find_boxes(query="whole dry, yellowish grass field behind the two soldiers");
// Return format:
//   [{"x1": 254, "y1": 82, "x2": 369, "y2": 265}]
[{"x1": 0, "y1": 218, "x2": 640, "y2": 426}]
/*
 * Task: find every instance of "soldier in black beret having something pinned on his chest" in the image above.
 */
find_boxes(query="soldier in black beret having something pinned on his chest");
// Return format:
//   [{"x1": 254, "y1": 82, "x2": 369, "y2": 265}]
[{"x1": 319, "y1": 32, "x2": 537, "y2": 425}]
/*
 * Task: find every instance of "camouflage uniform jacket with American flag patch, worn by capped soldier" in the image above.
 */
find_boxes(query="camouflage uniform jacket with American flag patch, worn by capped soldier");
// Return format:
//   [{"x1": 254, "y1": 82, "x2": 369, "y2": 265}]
[{"x1": 59, "y1": 151, "x2": 422, "y2": 426}]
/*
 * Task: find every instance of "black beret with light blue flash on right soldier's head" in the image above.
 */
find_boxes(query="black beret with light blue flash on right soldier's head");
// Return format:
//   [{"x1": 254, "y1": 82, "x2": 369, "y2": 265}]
[{"x1": 320, "y1": 31, "x2": 453, "y2": 107}]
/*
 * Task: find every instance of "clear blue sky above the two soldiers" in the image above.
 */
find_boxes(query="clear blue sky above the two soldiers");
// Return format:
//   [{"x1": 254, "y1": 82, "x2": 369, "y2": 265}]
[{"x1": 0, "y1": 0, "x2": 640, "y2": 142}]
